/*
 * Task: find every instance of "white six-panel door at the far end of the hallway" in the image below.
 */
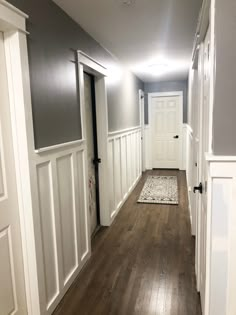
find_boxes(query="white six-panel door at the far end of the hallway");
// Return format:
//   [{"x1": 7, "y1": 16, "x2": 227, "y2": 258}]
[{"x1": 149, "y1": 96, "x2": 182, "y2": 169}]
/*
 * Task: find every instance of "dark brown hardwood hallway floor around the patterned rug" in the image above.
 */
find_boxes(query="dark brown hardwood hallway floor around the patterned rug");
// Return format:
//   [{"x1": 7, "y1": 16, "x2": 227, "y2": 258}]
[{"x1": 54, "y1": 170, "x2": 201, "y2": 315}]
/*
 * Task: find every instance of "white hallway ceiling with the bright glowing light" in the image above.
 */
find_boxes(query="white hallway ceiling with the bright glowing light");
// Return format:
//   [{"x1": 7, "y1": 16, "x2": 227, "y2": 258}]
[{"x1": 54, "y1": 0, "x2": 202, "y2": 82}]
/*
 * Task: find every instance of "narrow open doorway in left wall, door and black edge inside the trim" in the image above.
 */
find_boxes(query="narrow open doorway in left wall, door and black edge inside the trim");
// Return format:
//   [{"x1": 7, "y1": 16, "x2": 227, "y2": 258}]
[{"x1": 84, "y1": 72, "x2": 101, "y2": 237}]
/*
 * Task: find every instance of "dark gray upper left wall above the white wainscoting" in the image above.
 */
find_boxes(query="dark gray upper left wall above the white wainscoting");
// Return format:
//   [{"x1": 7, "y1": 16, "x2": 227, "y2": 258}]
[{"x1": 9, "y1": 0, "x2": 143, "y2": 148}]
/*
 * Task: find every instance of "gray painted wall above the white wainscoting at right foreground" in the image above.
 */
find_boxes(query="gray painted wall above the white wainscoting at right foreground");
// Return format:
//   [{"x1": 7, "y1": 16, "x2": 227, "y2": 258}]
[{"x1": 213, "y1": 0, "x2": 236, "y2": 155}]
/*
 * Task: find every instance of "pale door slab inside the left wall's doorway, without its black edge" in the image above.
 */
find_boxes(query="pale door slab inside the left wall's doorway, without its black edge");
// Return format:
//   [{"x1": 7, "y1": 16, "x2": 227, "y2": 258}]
[{"x1": 84, "y1": 73, "x2": 98, "y2": 235}]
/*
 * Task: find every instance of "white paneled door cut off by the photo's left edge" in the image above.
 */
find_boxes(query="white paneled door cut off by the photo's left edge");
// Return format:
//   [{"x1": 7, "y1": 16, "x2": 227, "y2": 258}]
[{"x1": 0, "y1": 32, "x2": 27, "y2": 315}]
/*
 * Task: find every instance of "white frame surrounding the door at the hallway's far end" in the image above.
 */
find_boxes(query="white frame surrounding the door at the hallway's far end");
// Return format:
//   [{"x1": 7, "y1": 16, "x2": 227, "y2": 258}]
[{"x1": 147, "y1": 91, "x2": 185, "y2": 170}]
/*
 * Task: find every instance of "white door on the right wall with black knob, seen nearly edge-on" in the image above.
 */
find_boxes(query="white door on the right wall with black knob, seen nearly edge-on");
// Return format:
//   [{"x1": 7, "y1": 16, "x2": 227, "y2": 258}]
[{"x1": 199, "y1": 25, "x2": 210, "y2": 314}]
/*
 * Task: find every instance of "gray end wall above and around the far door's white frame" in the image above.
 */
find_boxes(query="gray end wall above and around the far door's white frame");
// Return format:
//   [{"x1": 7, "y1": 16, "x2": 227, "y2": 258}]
[{"x1": 144, "y1": 80, "x2": 188, "y2": 124}]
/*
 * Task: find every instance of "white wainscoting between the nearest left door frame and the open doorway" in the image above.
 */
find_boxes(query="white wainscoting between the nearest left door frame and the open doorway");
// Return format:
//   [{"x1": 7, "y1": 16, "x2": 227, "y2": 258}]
[{"x1": 34, "y1": 141, "x2": 90, "y2": 315}]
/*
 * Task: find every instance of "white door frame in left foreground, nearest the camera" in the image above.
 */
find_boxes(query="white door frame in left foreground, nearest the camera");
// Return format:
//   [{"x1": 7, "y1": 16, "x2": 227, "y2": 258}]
[{"x1": 0, "y1": 0, "x2": 40, "y2": 315}]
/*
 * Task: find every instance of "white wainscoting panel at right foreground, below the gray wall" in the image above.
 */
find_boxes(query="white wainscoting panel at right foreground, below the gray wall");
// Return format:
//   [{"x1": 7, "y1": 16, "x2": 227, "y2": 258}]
[{"x1": 204, "y1": 155, "x2": 236, "y2": 315}]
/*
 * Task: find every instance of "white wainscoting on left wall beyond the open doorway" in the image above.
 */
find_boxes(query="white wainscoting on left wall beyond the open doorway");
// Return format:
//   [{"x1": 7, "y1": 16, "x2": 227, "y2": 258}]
[{"x1": 108, "y1": 127, "x2": 142, "y2": 221}]
